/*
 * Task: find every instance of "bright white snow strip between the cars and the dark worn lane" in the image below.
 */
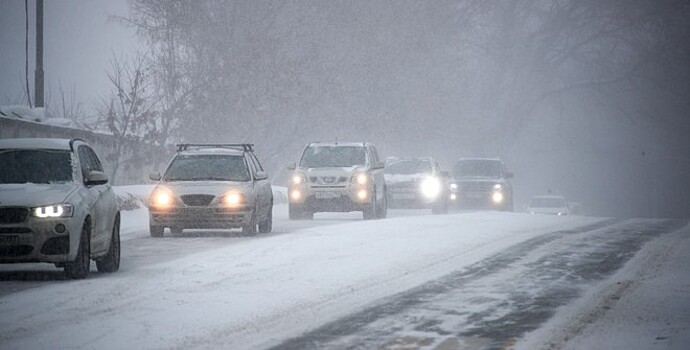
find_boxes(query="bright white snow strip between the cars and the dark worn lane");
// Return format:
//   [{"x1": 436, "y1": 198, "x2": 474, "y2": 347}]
[{"x1": 0, "y1": 186, "x2": 600, "y2": 349}]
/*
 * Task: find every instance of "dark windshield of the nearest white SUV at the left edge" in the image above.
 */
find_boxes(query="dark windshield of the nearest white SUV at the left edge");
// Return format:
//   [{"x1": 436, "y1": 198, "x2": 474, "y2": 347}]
[{"x1": 0, "y1": 149, "x2": 73, "y2": 184}]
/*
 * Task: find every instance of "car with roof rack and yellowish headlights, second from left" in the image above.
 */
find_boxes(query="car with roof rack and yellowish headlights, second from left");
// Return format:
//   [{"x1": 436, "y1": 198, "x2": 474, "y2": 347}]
[{"x1": 149, "y1": 143, "x2": 273, "y2": 237}]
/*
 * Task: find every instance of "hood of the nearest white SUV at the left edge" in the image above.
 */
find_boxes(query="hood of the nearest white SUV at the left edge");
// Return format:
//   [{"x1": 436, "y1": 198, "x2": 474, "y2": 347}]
[{"x1": 0, "y1": 183, "x2": 77, "y2": 207}]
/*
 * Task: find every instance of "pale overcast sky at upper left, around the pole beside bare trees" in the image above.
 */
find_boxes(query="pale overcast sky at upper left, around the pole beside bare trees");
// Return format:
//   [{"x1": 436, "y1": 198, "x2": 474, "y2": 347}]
[{"x1": 0, "y1": 0, "x2": 138, "y2": 113}]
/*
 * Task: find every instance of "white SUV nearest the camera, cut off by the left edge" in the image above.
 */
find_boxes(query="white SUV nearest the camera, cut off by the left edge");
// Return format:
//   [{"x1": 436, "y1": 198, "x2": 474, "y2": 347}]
[{"x1": 0, "y1": 138, "x2": 120, "y2": 278}]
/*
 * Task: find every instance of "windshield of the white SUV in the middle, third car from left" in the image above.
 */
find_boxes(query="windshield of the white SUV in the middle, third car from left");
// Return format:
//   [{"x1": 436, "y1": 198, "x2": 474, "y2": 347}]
[{"x1": 299, "y1": 146, "x2": 367, "y2": 168}]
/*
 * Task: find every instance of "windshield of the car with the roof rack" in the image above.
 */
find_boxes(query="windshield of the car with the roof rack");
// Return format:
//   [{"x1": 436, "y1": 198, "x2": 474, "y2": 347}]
[{"x1": 163, "y1": 154, "x2": 250, "y2": 181}]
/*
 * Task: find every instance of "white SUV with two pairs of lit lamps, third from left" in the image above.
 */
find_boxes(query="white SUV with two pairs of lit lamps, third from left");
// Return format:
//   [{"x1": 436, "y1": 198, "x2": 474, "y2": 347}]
[{"x1": 288, "y1": 142, "x2": 388, "y2": 220}]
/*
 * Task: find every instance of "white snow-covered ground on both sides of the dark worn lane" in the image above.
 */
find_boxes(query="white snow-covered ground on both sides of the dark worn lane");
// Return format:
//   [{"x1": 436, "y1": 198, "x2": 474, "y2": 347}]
[{"x1": 0, "y1": 186, "x2": 690, "y2": 349}]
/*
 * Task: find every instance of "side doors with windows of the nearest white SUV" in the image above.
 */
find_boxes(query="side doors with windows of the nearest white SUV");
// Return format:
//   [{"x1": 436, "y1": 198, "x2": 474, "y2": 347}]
[{"x1": 78, "y1": 145, "x2": 111, "y2": 253}]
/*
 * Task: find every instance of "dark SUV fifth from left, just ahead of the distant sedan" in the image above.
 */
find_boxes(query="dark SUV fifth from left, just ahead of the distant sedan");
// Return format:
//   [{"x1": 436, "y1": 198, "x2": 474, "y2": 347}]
[{"x1": 450, "y1": 158, "x2": 513, "y2": 211}]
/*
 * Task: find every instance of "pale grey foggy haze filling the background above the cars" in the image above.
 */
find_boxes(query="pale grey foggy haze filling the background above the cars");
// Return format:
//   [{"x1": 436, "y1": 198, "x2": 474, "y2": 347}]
[{"x1": 0, "y1": 0, "x2": 690, "y2": 217}]
